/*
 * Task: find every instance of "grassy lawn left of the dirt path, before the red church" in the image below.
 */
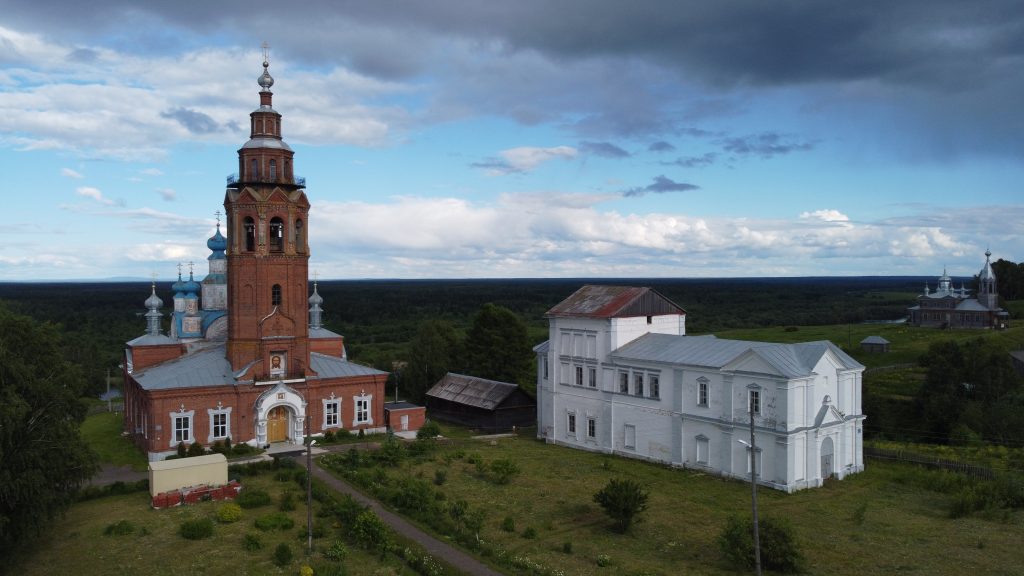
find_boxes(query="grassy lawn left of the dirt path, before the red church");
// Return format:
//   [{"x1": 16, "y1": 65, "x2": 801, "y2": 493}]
[{"x1": 11, "y1": 474, "x2": 408, "y2": 576}]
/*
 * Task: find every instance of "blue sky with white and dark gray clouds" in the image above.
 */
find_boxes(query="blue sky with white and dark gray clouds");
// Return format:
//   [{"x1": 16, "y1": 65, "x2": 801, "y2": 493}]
[{"x1": 0, "y1": 0, "x2": 1024, "y2": 281}]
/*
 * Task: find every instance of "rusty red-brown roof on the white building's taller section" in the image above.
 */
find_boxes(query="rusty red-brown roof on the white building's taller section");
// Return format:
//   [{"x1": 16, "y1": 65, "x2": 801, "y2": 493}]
[{"x1": 545, "y1": 284, "x2": 686, "y2": 318}]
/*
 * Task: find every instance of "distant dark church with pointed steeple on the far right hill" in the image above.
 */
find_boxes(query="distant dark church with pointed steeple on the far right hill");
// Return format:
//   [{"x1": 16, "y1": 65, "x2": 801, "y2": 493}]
[{"x1": 907, "y1": 250, "x2": 1010, "y2": 329}]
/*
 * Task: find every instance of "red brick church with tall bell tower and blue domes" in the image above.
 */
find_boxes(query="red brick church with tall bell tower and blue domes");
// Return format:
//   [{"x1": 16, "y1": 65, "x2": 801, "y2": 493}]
[{"x1": 124, "y1": 52, "x2": 388, "y2": 460}]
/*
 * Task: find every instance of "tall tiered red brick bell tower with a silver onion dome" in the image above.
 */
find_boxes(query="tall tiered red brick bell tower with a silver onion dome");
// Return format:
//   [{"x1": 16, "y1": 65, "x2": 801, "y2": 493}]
[{"x1": 224, "y1": 44, "x2": 309, "y2": 380}]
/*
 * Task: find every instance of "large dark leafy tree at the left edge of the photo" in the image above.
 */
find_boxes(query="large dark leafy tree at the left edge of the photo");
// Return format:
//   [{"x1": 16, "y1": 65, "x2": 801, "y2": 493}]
[{"x1": 0, "y1": 306, "x2": 95, "y2": 557}]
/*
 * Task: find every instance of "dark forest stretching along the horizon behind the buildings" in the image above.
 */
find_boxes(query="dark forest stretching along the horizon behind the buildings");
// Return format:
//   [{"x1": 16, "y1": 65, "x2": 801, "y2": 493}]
[{"x1": 0, "y1": 270, "x2": 1020, "y2": 393}]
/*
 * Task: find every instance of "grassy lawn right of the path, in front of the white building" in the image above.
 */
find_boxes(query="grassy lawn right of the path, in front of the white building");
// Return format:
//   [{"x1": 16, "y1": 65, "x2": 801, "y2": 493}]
[{"x1": 339, "y1": 437, "x2": 1024, "y2": 576}]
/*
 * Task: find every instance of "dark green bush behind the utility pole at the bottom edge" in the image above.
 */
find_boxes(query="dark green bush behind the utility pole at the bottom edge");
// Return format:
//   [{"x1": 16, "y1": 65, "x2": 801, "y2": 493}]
[{"x1": 718, "y1": 516, "x2": 803, "y2": 572}]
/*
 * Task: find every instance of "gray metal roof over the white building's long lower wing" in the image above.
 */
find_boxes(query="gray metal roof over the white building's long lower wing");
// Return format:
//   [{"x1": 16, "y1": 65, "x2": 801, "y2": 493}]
[{"x1": 611, "y1": 334, "x2": 863, "y2": 378}]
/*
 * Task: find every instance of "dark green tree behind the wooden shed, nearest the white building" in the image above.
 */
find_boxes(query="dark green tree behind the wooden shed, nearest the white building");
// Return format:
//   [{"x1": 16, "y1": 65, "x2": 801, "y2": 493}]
[{"x1": 465, "y1": 303, "x2": 536, "y2": 386}]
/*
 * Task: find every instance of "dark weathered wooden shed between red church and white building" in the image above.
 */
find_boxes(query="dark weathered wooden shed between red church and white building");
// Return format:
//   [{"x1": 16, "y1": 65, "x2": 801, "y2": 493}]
[{"x1": 427, "y1": 372, "x2": 537, "y2": 431}]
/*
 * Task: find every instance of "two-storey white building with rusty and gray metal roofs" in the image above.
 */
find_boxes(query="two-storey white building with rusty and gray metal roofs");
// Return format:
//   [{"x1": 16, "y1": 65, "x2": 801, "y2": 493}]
[{"x1": 535, "y1": 286, "x2": 864, "y2": 492}]
